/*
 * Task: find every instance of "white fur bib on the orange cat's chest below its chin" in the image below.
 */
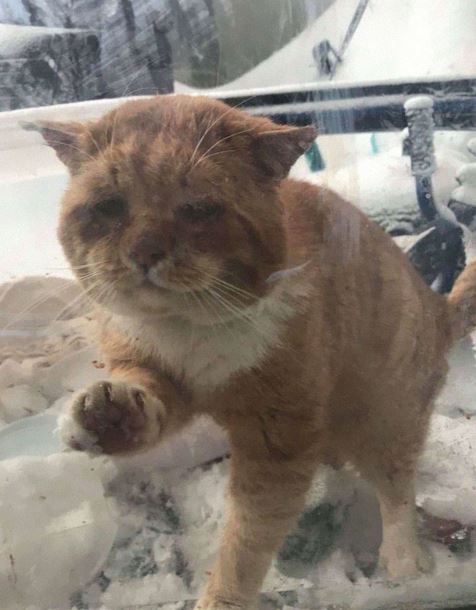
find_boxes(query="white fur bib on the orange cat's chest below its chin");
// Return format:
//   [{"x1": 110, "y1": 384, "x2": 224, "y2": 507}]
[{"x1": 114, "y1": 287, "x2": 303, "y2": 389}]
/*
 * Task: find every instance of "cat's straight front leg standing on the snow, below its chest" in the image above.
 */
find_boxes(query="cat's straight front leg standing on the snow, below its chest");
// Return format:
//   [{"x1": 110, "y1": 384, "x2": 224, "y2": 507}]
[{"x1": 195, "y1": 446, "x2": 315, "y2": 610}]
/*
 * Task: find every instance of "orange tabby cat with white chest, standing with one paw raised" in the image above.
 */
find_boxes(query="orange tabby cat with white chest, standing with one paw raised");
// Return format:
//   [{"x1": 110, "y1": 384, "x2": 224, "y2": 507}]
[{"x1": 27, "y1": 96, "x2": 476, "y2": 610}]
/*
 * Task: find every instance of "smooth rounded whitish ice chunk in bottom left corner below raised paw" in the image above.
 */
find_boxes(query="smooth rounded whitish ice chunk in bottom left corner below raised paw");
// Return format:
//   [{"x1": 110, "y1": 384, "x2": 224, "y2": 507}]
[{"x1": 0, "y1": 453, "x2": 117, "y2": 610}]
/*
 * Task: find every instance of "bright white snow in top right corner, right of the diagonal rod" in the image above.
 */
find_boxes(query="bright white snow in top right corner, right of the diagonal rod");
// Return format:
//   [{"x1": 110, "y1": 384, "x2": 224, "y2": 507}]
[{"x1": 335, "y1": 0, "x2": 476, "y2": 81}]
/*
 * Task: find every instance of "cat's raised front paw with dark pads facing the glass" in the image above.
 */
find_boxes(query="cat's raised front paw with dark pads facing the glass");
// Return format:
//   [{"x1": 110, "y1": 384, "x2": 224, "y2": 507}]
[{"x1": 60, "y1": 381, "x2": 164, "y2": 454}]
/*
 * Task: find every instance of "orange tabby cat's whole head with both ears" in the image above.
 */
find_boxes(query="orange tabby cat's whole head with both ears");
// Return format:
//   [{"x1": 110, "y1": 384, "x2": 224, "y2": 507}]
[{"x1": 32, "y1": 96, "x2": 315, "y2": 324}]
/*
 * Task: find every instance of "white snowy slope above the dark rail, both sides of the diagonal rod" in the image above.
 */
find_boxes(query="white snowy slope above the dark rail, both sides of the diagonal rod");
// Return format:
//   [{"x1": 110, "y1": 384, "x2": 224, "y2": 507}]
[{"x1": 196, "y1": 0, "x2": 476, "y2": 92}]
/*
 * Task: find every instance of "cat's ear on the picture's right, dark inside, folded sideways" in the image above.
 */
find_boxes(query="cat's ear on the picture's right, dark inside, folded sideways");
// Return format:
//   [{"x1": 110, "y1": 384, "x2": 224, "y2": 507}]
[{"x1": 255, "y1": 125, "x2": 317, "y2": 180}]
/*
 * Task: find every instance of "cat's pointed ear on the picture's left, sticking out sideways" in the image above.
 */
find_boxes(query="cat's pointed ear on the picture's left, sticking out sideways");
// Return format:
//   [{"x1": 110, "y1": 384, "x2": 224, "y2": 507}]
[{"x1": 20, "y1": 121, "x2": 85, "y2": 173}]
